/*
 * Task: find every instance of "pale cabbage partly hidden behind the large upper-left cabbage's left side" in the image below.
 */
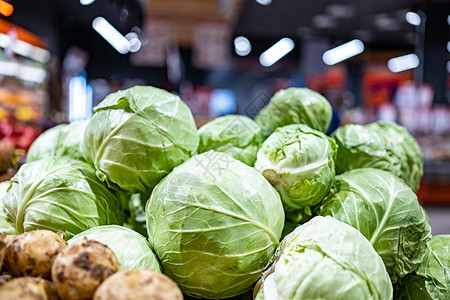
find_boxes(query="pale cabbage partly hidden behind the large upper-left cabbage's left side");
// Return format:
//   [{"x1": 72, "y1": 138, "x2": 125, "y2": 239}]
[{"x1": 27, "y1": 120, "x2": 89, "y2": 162}]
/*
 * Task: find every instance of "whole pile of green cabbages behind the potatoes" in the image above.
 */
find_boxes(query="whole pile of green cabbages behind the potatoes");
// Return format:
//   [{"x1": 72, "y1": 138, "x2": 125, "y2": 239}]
[{"x1": 0, "y1": 86, "x2": 450, "y2": 300}]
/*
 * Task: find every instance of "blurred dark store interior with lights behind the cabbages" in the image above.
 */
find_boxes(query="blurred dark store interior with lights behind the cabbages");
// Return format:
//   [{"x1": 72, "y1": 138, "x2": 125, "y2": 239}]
[{"x1": 0, "y1": 0, "x2": 450, "y2": 234}]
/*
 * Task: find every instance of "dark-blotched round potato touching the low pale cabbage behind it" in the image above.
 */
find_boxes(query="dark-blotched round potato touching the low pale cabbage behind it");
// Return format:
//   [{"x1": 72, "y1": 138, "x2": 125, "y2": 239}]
[{"x1": 52, "y1": 238, "x2": 119, "y2": 300}]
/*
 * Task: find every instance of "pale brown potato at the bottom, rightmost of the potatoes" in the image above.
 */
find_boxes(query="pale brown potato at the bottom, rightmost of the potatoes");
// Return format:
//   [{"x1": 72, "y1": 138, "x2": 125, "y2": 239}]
[{"x1": 92, "y1": 269, "x2": 183, "y2": 300}]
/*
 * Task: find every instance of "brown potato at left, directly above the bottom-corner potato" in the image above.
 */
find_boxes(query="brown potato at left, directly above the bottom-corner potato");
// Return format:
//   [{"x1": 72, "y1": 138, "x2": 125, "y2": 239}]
[{"x1": 6, "y1": 230, "x2": 67, "y2": 279}]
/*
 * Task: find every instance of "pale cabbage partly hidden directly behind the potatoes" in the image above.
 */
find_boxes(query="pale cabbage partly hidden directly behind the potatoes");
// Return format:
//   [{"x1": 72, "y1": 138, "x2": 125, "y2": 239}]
[{"x1": 67, "y1": 225, "x2": 161, "y2": 272}]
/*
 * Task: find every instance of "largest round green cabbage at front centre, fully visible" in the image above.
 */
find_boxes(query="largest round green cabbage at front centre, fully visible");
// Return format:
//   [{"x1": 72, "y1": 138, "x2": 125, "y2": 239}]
[{"x1": 146, "y1": 150, "x2": 284, "y2": 299}]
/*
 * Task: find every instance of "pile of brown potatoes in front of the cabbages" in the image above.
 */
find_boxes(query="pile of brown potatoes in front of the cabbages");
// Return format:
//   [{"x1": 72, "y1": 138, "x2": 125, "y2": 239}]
[{"x1": 0, "y1": 230, "x2": 183, "y2": 300}]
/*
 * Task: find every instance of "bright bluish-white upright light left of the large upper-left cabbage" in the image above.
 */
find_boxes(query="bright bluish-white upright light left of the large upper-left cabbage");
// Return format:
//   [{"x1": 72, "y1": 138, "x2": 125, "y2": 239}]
[{"x1": 69, "y1": 76, "x2": 92, "y2": 122}]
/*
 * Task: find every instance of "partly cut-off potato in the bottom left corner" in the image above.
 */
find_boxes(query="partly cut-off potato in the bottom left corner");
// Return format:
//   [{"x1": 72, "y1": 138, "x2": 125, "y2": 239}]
[{"x1": 0, "y1": 277, "x2": 58, "y2": 300}]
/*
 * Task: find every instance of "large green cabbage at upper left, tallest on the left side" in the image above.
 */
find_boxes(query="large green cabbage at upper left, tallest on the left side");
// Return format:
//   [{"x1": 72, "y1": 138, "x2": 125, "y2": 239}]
[{"x1": 83, "y1": 86, "x2": 198, "y2": 195}]
